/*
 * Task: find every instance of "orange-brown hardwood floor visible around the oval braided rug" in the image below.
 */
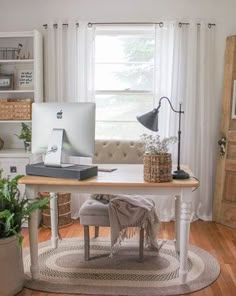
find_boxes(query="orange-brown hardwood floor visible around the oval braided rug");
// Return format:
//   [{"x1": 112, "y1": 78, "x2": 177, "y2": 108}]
[{"x1": 18, "y1": 221, "x2": 236, "y2": 296}]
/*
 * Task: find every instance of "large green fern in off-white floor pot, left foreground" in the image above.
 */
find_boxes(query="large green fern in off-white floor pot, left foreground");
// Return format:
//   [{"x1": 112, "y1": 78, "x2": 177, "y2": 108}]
[{"x1": 0, "y1": 171, "x2": 48, "y2": 296}]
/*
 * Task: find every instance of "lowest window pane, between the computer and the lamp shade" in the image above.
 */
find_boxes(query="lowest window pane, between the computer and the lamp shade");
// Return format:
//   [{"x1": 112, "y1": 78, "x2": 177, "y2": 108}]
[{"x1": 96, "y1": 121, "x2": 148, "y2": 140}]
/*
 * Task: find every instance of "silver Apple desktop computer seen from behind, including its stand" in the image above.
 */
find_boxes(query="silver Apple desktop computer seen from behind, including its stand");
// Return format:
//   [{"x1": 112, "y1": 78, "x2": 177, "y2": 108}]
[{"x1": 32, "y1": 103, "x2": 95, "y2": 167}]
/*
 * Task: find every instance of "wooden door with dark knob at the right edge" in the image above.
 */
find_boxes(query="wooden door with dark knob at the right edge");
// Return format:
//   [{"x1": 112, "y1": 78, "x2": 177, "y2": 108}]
[{"x1": 213, "y1": 36, "x2": 236, "y2": 228}]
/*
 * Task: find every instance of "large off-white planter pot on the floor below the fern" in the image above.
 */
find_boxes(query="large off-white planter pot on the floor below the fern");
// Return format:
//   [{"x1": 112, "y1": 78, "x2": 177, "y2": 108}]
[{"x1": 0, "y1": 236, "x2": 24, "y2": 296}]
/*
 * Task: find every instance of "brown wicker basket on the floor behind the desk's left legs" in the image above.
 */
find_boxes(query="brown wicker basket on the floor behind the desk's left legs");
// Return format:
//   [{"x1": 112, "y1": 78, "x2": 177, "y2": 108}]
[{"x1": 40, "y1": 192, "x2": 73, "y2": 228}]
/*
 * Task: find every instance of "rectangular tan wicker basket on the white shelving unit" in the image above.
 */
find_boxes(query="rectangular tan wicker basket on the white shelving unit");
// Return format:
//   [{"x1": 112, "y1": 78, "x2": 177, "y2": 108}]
[{"x1": 0, "y1": 99, "x2": 32, "y2": 120}]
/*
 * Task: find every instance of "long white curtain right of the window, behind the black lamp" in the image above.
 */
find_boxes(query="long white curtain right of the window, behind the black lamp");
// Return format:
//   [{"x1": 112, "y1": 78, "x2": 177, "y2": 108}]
[{"x1": 155, "y1": 23, "x2": 218, "y2": 221}]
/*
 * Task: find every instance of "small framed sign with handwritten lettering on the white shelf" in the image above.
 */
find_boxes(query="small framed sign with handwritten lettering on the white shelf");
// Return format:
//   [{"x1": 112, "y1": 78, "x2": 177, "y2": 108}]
[{"x1": 16, "y1": 69, "x2": 34, "y2": 90}]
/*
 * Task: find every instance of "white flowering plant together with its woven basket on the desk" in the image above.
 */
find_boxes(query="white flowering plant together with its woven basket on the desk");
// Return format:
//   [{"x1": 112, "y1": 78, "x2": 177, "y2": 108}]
[{"x1": 141, "y1": 134, "x2": 177, "y2": 182}]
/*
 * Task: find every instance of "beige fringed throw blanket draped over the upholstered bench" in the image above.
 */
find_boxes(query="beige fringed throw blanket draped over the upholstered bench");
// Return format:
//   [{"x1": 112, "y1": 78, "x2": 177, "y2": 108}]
[{"x1": 108, "y1": 195, "x2": 160, "y2": 250}]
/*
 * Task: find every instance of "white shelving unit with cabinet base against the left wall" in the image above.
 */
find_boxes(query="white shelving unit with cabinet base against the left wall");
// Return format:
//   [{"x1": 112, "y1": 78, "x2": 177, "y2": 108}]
[{"x1": 0, "y1": 30, "x2": 43, "y2": 176}]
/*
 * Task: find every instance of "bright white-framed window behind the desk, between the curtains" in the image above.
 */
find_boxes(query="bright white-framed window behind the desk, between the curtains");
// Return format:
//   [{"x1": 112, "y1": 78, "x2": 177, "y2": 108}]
[{"x1": 95, "y1": 26, "x2": 155, "y2": 139}]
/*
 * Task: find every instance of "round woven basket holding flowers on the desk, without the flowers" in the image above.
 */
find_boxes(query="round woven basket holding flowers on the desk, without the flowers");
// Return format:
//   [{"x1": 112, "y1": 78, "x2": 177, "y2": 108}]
[{"x1": 143, "y1": 153, "x2": 172, "y2": 183}]
